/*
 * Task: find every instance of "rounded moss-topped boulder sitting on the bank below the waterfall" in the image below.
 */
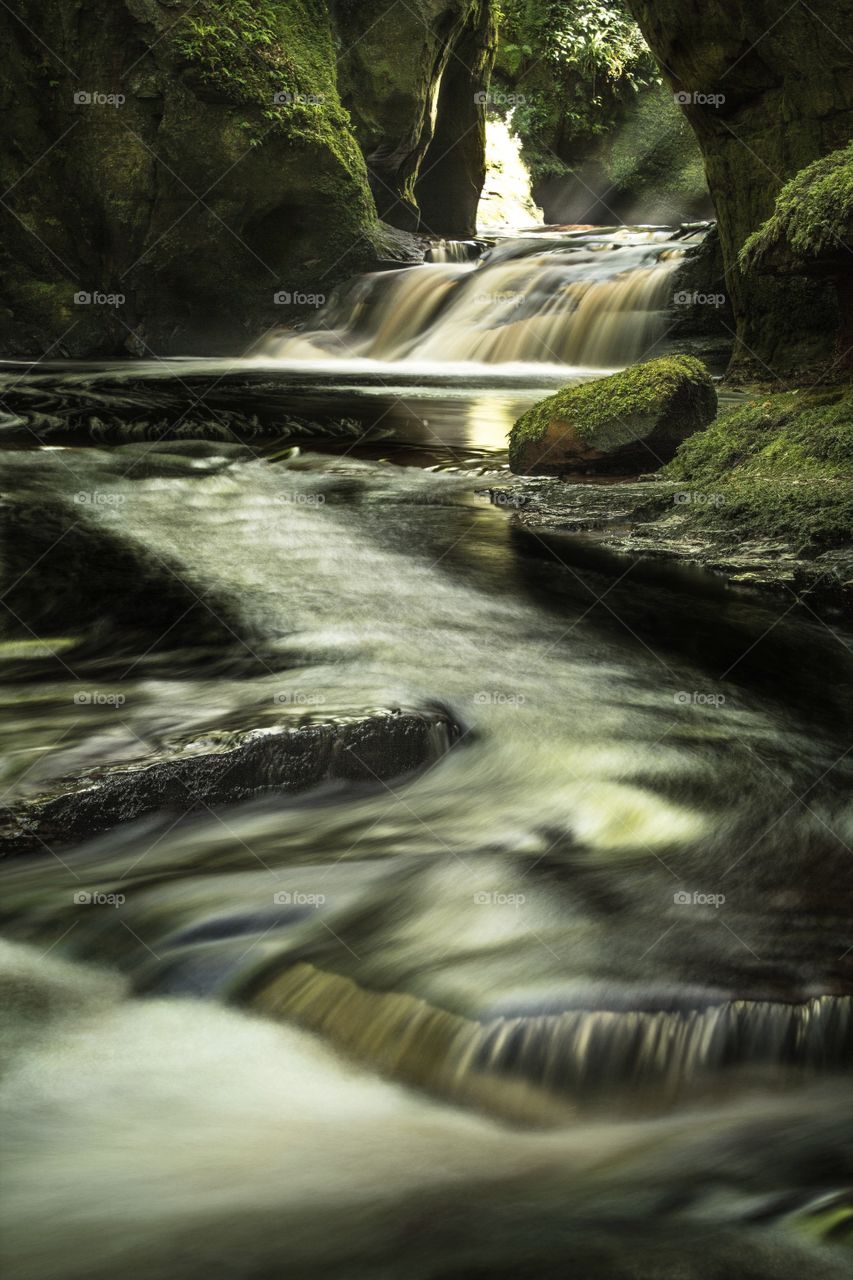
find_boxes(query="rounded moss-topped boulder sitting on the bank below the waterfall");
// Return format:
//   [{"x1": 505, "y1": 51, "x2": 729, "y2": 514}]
[{"x1": 510, "y1": 356, "x2": 717, "y2": 475}]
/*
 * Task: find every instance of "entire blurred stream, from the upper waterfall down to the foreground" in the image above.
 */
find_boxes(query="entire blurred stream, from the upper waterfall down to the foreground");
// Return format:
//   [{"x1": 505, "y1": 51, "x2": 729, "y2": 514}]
[{"x1": 0, "y1": 232, "x2": 853, "y2": 1280}]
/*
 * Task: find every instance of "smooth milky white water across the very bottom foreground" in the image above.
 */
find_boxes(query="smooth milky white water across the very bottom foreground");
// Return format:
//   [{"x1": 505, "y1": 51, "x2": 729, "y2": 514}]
[{"x1": 0, "y1": 943, "x2": 849, "y2": 1280}]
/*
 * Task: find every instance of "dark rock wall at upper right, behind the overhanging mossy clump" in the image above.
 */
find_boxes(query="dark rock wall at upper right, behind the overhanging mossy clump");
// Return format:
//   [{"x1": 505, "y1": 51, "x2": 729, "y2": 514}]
[{"x1": 629, "y1": 0, "x2": 853, "y2": 380}]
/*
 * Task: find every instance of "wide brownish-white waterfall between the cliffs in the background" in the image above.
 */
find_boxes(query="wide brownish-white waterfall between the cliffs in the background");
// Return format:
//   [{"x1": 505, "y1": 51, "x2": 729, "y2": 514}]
[{"x1": 263, "y1": 229, "x2": 684, "y2": 369}]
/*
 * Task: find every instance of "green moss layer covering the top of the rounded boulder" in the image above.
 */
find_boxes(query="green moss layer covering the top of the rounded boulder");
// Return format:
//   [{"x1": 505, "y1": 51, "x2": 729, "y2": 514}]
[{"x1": 510, "y1": 356, "x2": 711, "y2": 466}]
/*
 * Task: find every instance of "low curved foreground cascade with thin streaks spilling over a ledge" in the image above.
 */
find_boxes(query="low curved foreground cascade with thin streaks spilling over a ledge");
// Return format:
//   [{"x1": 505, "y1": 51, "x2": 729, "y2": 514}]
[{"x1": 242, "y1": 964, "x2": 853, "y2": 1119}]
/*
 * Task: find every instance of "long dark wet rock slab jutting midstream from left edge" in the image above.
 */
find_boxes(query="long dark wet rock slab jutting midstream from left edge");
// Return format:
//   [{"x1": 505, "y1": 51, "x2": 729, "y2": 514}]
[{"x1": 0, "y1": 708, "x2": 459, "y2": 854}]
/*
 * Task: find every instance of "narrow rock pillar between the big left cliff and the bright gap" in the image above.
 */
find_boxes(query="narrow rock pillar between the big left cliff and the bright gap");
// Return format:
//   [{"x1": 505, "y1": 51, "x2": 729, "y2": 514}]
[{"x1": 330, "y1": 0, "x2": 497, "y2": 239}]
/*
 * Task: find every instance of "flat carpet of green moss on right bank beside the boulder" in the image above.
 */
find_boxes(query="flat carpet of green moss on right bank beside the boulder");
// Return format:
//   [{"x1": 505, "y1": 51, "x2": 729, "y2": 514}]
[{"x1": 663, "y1": 388, "x2": 853, "y2": 550}]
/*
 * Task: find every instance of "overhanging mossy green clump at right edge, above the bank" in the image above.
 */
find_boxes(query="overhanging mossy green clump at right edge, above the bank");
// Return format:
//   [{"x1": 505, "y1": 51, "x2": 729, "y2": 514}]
[{"x1": 739, "y1": 142, "x2": 853, "y2": 270}]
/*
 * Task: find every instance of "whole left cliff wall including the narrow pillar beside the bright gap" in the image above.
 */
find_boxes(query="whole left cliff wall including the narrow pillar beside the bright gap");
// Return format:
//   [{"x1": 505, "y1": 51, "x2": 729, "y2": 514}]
[{"x1": 0, "y1": 0, "x2": 493, "y2": 357}]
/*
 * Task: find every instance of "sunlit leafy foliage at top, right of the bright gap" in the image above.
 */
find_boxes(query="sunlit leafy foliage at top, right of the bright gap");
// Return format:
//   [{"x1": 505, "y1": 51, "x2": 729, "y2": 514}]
[{"x1": 496, "y1": 0, "x2": 657, "y2": 178}]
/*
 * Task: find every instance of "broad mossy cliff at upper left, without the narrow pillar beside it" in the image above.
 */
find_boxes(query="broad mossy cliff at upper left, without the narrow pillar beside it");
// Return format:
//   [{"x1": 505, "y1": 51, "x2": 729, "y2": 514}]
[{"x1": 0, "y1": 0, "x2": 377, "y2": 355}]
